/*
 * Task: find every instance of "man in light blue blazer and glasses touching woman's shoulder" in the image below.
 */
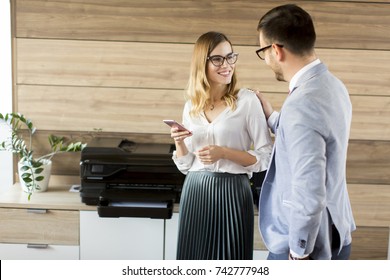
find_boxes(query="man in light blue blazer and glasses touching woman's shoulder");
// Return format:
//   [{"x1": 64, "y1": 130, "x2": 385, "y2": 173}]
[{"x1": 256, "y1": 4, "x2": 356, "y2": 260}]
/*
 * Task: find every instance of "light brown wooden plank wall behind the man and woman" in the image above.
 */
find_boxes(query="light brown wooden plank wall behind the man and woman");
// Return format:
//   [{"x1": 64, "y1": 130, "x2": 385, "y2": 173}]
[{"x1": 11, "y1": 0, "x2": 390, "y2": 258}]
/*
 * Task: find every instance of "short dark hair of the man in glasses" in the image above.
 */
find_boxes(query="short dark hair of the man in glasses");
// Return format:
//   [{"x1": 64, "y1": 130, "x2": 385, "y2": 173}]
[{"x1": 257, "y1": 4, "x2": 316, "y2": 55}]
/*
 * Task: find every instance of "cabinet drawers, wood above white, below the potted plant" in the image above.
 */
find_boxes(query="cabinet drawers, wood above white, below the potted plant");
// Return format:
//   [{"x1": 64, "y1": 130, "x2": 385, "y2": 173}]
[{"x1": 0, "y1": 208, "x2": 79, "y2": 260}]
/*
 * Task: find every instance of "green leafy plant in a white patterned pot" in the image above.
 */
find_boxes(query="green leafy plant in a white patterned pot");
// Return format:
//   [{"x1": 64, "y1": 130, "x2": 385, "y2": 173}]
[{"x1": 0, "y1": 113, "x2": 87, "y2": 200}]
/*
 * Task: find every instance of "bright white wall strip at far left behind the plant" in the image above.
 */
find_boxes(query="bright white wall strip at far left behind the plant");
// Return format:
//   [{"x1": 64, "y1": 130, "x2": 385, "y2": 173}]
[{"x1": 0, "y1": 1, "x2": 13, "y2": 195}]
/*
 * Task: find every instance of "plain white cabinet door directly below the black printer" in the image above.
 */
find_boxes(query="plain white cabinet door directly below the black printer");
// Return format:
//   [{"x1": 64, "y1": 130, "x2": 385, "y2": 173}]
[{"x1": 80, "y1": 211, "x2": 165, "y2": 260}]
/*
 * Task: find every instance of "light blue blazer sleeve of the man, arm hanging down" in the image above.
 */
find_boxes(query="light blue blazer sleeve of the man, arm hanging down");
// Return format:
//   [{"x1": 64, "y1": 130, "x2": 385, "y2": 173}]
[{"x1": 283, "y1": 99, "x2": 327, "y2": 256}]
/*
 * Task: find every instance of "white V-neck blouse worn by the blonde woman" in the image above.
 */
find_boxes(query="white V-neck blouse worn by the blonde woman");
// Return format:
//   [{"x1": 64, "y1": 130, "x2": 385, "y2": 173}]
[{"x1": 172, "y1": 89, "x2": 272, "y2": 178}]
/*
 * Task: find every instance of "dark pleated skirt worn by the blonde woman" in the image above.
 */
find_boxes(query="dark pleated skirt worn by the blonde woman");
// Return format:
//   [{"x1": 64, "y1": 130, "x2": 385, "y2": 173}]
[{"x1": 176, "y1": 171, "x2": 254, "y2": 260}]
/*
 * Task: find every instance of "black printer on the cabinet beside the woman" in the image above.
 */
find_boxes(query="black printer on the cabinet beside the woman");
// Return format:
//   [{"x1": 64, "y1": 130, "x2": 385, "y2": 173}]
[{"x1": 80, "y1": 137, "x2": 185, "y2": 219}]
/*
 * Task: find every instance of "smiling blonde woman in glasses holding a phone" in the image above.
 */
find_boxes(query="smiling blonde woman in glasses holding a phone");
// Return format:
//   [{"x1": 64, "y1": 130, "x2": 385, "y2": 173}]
[{"x1": 171, "y1": 32, "x2": 271, "y2": 260}]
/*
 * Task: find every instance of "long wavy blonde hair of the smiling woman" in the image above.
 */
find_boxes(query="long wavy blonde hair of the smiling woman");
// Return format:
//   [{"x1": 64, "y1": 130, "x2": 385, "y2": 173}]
[{"x1": 185, "y1": 31, "x2": 238, "y2": 117}]
